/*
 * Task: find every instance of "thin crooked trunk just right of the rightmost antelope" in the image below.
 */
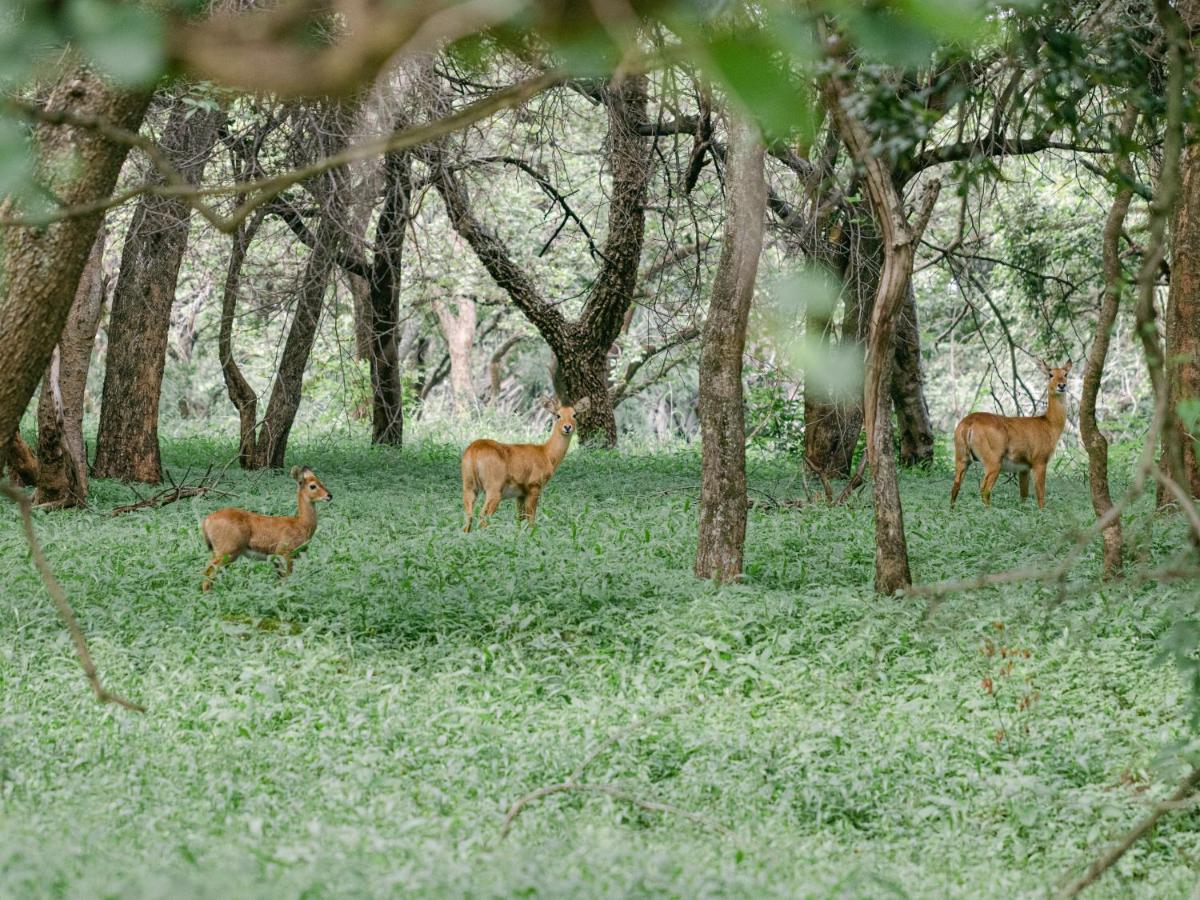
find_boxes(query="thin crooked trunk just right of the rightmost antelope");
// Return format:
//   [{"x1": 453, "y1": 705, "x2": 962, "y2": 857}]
[{"x1": 1079, "y1": 104, "x2": 1138, "y2": 578}]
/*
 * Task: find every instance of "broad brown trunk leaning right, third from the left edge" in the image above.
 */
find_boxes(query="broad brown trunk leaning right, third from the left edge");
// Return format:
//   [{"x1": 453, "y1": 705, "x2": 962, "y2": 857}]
[{"x1": 92, "y1": 98, "x2": 224, "y2": 484}]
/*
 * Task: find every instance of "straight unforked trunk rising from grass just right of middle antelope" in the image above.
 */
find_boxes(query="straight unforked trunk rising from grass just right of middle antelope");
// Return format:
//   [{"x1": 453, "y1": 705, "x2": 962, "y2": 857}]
[{"x1": 696, "y1": 114, "x2": 767, "y2": 582}]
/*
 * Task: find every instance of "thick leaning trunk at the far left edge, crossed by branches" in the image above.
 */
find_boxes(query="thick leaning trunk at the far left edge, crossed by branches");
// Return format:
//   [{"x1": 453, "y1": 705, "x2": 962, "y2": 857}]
[{"x1": 0, "y1": 67, "x2": 149, "y2": 446}]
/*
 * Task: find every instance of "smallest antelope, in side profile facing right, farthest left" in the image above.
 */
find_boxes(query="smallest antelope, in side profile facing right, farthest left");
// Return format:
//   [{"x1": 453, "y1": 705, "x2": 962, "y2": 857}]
[{"x1": 200, "y1": 466, "x2": 334, "y2": 590}]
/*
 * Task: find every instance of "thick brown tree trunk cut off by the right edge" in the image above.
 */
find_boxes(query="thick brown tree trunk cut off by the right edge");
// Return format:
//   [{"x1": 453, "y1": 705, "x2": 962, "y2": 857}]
[{"x1": 1158, "y1": 144, "x2": 1200, "y2": 506}]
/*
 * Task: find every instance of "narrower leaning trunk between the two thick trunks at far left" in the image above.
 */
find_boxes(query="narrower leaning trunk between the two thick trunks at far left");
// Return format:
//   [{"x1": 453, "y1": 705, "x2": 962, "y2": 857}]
[{"x1": 34, "y1": 228, "x2": 104, "y2": 506}]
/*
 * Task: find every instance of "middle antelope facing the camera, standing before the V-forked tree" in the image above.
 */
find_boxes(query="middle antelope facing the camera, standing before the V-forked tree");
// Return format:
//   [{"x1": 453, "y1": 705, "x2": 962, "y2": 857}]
[{"x1": 462, "y1": 397, "x2": 590, "y2": 532}]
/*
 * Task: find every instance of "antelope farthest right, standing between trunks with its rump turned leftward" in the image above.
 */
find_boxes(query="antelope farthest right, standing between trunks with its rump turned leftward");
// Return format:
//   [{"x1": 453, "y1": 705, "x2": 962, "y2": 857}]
[{"x1": 950, "y1": 360, "x2": 1070, "y2": 509}]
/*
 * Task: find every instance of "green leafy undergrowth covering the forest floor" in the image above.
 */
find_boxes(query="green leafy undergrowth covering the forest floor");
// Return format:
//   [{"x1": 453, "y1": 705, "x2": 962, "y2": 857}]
[{"x1": 0, "y1": 439, "x2": 1200, "y2": 898}]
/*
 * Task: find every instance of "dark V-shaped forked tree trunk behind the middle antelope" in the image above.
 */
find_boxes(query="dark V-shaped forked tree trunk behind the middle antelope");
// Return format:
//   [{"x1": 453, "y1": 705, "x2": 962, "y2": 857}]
[{"x1": 434, "y1": 76, "x2": 653, "y2": 446}]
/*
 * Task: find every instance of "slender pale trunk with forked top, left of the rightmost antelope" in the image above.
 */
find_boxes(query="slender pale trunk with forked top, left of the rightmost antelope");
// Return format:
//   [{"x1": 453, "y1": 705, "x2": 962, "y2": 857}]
[{"x1": 822, "y1": 60, "x2": 937, "y2": 594}]
